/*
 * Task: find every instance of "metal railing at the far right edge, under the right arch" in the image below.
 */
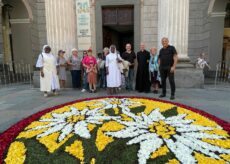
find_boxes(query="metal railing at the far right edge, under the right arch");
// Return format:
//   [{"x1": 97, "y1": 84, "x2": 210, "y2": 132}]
[{"x1": 215, "y1": 62, "x2": 230, "y2": 87}]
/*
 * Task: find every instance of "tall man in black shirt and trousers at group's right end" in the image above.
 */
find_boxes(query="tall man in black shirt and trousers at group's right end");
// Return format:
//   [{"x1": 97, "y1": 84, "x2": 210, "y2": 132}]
[{"x1": 158, "y1": 38, "x2": 178, "y2": 100}]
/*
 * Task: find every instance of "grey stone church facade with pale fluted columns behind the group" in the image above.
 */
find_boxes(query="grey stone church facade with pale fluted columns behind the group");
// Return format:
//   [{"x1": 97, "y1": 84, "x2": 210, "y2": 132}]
[{"x1": 0, "y1": 0, "x2": 230, "y2": 71}]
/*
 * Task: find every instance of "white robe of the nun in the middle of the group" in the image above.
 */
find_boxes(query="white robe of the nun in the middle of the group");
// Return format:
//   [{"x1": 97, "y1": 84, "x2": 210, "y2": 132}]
[{"x1": 105, "y1": 53, "x2": 121, "y2": 88}]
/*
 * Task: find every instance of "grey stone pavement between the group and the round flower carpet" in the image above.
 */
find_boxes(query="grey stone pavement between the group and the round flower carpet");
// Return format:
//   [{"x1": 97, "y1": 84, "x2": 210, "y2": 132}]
[{"x1": 0, "y1": 85, "x2": 230, "y2": 133}]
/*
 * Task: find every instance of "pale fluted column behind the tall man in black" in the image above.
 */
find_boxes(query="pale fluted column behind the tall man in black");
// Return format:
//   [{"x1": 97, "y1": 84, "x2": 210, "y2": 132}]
[{"x1": 158, "y1": 0, "x2": 189, "y2": 61}]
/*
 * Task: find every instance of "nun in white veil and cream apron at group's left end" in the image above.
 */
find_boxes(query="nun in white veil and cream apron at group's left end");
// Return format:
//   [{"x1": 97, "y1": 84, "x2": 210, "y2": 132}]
[{"x1": 36, "y1": 45, "x2": 60, "y2": 97}]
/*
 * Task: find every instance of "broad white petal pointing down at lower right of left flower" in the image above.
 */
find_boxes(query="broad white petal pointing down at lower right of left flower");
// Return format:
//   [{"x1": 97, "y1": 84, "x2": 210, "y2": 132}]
[{"x1": 74, "y1": 121, "x2": 91, "y2": 139}]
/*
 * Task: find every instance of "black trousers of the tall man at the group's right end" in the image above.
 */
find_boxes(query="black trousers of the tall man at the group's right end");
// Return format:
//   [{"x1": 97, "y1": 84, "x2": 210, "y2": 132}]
[{"x1": 160, "y1": 69, "x2": 176, "y2": 96}]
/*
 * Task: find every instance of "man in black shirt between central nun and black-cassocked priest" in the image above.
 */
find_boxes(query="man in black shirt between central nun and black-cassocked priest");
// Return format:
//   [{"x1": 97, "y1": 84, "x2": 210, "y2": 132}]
[{"x1": 122, "y1": 43, "x2": 136, "y2": 90}]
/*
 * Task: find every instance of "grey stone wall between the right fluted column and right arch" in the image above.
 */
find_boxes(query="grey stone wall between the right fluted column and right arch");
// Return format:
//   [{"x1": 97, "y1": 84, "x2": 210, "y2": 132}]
[{"x1": 188, "y1": 0, "x2": 210, "y2": 62}]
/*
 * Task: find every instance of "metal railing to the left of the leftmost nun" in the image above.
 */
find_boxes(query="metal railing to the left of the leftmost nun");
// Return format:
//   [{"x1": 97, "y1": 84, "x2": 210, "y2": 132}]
[{"x1": 0, "y1": 62, "x2": 33, "y2": 87}]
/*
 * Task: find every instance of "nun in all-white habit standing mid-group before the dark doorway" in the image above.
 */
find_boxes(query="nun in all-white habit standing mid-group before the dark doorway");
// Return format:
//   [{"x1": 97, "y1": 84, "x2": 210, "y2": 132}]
[{"x1": 105, "y1": 45, "x2": 122, "y2": 94}]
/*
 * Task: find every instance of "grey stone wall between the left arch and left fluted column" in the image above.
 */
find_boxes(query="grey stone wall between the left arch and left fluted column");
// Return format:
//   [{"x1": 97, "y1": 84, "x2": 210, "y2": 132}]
[{"x1": 29, "y1": 0, "x2": 47, "y2": 67}]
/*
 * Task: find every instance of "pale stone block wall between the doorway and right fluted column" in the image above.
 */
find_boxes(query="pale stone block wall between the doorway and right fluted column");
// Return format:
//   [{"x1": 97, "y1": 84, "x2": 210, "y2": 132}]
[{"x1": 141, "y1": 0, "x2": 158, "y2": 49}]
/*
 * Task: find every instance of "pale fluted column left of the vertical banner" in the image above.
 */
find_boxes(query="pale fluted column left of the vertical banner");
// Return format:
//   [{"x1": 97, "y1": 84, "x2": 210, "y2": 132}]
[{"x1": 45, "y1": 0, "x2": 76, "y2": 55}]
